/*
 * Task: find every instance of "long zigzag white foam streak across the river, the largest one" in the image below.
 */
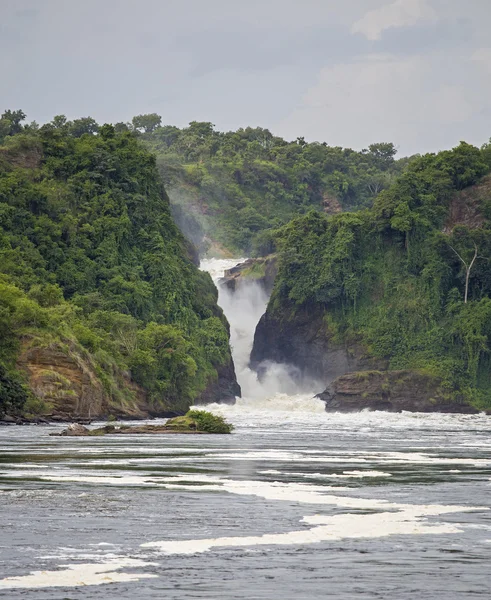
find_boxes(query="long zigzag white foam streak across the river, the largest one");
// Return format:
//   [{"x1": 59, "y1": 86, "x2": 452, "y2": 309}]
[{"x1": 142, "y1": 475, "x2": 489, "y2": 554}]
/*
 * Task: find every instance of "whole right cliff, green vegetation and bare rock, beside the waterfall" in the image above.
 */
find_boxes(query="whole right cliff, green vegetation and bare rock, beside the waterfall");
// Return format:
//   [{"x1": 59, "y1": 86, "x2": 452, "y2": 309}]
[{"x1": 251, "y1": 143, "x2": 491, "y2": 412}]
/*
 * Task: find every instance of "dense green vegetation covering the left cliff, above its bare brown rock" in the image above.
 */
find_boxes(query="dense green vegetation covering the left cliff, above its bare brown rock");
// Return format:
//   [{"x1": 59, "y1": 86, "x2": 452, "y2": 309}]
[{"x1": 0, "y1": 111, "x2": 234, "y2": 413}]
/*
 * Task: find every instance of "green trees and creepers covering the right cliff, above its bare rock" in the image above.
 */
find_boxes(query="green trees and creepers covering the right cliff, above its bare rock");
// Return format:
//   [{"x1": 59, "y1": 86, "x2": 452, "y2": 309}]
[{"x1": 268, "y1": 143, "x2": 491, "y2": 408}]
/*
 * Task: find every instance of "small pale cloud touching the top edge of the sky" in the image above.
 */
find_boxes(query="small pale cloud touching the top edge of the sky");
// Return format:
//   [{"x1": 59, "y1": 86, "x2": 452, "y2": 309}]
[{"x1": 351, "y1": 0, "x2": 437, "y2": 40}]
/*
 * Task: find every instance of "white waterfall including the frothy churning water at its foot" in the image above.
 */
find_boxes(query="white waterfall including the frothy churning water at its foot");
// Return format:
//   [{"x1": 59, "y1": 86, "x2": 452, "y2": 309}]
[{"x1": 200, "y1": 258, "x2": 325, "y2": 414}]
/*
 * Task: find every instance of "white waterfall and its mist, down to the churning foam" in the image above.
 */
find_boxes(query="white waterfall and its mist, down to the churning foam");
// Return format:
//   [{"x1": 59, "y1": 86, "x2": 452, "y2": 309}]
[{"x1": 201, "y1": 259, "x2": 323, "y2": 405}]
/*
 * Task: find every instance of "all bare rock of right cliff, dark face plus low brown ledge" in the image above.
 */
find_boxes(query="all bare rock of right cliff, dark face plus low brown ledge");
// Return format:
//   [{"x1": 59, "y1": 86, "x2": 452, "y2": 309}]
[{"x1": 251, "y1": 309, "x2": 477, "y2": 413}]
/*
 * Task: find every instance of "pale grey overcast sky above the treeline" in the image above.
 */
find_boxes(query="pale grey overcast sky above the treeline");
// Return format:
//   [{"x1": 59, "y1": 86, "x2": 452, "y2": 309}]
[{"x1": 0, "y1": 0, "x2": 491, "y2": 156}]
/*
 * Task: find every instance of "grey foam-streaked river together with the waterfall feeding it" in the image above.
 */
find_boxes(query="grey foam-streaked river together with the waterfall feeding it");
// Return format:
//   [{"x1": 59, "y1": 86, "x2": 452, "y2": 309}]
[{"x1": 0, "y1": 263, "x2": 491, "y2": 600}]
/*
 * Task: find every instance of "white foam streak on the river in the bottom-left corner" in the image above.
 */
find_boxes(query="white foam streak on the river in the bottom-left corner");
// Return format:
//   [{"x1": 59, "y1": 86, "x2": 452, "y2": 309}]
[{"x1": 0, "y1": 557, "x2": 158, "y2": 590}]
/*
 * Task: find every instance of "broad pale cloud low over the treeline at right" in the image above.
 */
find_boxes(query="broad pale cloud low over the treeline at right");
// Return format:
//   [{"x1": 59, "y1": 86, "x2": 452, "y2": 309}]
[{"x1": 277, "y1": 53, "x2": 491, "y2": 155}]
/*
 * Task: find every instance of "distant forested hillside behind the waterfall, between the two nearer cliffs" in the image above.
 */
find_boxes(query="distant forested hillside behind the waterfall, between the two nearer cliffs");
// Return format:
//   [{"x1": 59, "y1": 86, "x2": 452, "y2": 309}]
[{"x1": 120, "y1": 115, "x2": 408, "y2": 255}]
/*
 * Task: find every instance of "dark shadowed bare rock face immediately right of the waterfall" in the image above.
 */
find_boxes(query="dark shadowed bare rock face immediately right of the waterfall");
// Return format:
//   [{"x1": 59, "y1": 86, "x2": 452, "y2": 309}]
[{"x1": 250, "y1": 309, "x2": 386, "y2": 384}]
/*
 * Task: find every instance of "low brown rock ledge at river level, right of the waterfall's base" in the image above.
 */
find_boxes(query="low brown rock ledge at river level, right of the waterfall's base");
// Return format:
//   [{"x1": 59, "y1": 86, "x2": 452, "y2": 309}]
[{"x1": 318, "y1": 371, "x2": 477, "y2": 413}]
